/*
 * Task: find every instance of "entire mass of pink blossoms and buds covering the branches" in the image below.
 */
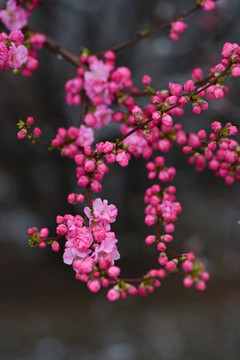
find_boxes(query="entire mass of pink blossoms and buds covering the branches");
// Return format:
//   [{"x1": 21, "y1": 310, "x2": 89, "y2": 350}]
[{"x1": 8, "y1": 0, "x2": 240, "y2": 301}]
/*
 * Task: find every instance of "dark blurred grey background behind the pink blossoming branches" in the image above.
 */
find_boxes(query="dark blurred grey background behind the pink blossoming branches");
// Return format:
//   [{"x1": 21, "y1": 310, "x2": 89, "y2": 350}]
[{"x1": 0, "y1": 0, "x2": 240, "y2": 360}]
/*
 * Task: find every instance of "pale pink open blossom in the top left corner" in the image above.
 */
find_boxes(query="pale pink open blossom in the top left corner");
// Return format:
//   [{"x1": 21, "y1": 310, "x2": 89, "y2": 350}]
[{"x1": 0, "y1": 0, "x2": 30, "y2": 30}]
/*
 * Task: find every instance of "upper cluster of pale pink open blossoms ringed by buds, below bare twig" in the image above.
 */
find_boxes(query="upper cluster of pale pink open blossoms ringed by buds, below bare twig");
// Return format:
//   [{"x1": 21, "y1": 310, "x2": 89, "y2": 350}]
[{"x1": 65, "y1": 51, "x2": 132, "y2": 129}]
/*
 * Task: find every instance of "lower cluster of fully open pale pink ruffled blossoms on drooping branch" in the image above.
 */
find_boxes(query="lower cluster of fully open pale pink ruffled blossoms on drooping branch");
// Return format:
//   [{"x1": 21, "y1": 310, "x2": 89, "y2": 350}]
[{"x1": 57, "y1": 198, "x2": 120, "y2": 265}]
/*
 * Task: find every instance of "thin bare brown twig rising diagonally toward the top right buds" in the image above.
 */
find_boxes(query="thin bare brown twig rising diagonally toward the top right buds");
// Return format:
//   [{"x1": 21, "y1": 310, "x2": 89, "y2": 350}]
[{"x1": 99, "y1": 5, "x2": 201, "y2": 55}]
